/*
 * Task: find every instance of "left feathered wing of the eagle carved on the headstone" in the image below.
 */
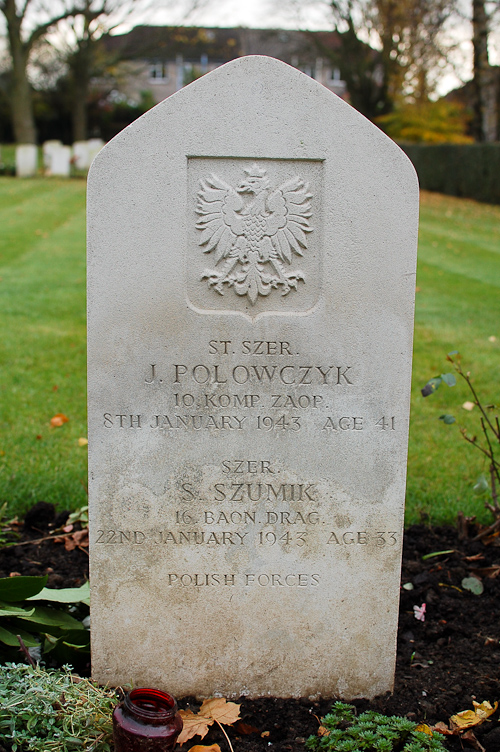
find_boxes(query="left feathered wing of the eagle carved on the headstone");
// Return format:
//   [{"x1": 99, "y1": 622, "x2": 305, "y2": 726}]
[{"x1": 196, "y1": 174, "x2": 244, "y2": 264}]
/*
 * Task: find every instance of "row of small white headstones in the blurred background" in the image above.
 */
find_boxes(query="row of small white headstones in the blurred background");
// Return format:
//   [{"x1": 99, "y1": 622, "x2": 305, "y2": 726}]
[{"x1": 16, "y1": 138, "x2": 104, "y2": 178}]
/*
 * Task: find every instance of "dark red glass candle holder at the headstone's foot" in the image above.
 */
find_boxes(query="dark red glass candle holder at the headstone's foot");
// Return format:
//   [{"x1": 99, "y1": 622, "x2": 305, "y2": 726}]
[{"x1": 113, "y1": 688, "x2": 182, "y2": 752}]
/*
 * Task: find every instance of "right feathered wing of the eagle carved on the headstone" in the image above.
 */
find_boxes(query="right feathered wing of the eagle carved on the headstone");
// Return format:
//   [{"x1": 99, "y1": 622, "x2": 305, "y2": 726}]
[{"x1": 266, "y1": 177, "x2": 313, "y2": 264}]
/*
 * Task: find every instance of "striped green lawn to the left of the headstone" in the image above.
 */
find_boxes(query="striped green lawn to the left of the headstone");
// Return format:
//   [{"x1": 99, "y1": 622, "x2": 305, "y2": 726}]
[{"x1": 0, "y1": 178, "x2": 87, "y2": 514}]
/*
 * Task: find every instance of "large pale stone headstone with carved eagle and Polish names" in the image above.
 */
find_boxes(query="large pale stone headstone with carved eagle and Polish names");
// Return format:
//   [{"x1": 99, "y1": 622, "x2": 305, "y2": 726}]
[{"x1": 88, "y1": 57, "x2": 418, "y2": 698}]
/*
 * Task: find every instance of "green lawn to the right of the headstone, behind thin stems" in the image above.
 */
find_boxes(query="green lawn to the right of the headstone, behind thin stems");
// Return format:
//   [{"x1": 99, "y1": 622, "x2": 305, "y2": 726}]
[{"x1": 407, "y1": 193, "x2": 500, "y2": 522}]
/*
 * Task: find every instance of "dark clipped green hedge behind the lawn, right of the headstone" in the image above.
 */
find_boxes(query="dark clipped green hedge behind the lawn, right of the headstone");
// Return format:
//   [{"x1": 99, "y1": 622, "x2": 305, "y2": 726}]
[{"x1": 400, "y1": 143, "x2": 500, "y2": 204}]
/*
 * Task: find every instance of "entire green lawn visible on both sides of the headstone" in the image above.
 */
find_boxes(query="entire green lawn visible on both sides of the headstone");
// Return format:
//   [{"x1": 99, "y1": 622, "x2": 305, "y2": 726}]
[{"x1": 0, "y1": 178, "x2": 500, "y2": 522}]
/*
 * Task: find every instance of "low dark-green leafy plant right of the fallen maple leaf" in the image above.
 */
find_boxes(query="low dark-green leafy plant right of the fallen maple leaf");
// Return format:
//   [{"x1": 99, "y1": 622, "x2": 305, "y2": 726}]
[{"x1": 306, "y1": 702, "x2": 446, "y2": 752}]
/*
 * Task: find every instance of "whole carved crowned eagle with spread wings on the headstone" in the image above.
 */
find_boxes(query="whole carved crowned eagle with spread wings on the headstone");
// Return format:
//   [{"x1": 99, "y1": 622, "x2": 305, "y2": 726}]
[{"x1": 196, "y1": 163, "x2": 313, "y2": 305}]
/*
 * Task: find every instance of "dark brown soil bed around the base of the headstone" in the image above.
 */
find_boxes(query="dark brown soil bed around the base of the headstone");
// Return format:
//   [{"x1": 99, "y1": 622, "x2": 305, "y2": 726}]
[{"x1": 0, "y1": 505, "x2": 500, "y2": 752}]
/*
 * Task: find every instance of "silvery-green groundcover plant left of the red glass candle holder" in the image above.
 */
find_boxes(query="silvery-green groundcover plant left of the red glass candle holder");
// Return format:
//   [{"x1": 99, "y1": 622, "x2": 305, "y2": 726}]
[{"x1": 0, "y1": 663, "x2": 117, "y2": 752}]
